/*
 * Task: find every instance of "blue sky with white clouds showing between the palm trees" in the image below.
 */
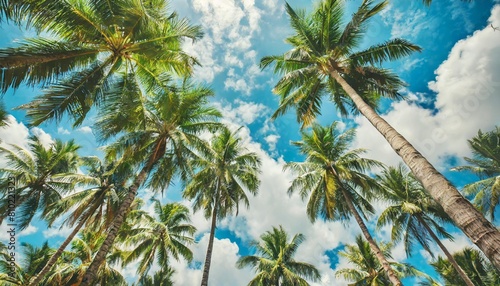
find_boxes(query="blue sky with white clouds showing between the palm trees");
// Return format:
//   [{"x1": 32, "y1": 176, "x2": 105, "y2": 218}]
[{"x1": 0, "y1": 0, "x2": 500, "y2": 286}]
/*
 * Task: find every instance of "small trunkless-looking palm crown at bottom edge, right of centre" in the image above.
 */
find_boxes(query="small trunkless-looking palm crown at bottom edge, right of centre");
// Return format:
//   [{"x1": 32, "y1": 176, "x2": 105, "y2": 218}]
[{"x1": 236, "y1": 226, "x2": 321, "y2": 286}]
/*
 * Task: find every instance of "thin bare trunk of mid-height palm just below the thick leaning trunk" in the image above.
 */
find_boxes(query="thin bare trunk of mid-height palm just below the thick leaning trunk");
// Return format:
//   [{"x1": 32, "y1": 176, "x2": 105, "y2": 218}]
[{"x1": 342, "y1": 188, "x2": 403, "y2": 286}]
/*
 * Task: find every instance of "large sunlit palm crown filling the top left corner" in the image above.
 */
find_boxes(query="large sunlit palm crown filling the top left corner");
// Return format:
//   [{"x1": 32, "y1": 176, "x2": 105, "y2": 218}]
[{"x1": 0, "y1": 0, "x2": 202, "y2": 125}]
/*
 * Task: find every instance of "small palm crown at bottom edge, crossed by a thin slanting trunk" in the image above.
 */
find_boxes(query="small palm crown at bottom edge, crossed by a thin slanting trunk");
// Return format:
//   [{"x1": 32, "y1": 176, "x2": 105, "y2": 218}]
[{"x1": 335, "y1": 235, "x2": 427, "y2": 286}]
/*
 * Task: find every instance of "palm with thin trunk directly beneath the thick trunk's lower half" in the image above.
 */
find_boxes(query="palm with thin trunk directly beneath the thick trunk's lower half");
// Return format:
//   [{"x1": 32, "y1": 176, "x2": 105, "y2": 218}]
[{"x1": 377, "y1": 165, "x2": 474, "y2": 286}]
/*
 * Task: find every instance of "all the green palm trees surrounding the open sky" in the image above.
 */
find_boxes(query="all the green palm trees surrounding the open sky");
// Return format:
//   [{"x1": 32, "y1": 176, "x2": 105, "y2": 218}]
[{"x1": 0, "y1": 0, "x2": 500, "y2": 285}]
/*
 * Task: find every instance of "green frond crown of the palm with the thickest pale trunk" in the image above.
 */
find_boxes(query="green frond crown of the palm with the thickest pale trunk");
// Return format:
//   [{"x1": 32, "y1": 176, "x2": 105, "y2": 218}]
[{"x1": 261, "y1": 0, "x2": 420, "y2": 126}]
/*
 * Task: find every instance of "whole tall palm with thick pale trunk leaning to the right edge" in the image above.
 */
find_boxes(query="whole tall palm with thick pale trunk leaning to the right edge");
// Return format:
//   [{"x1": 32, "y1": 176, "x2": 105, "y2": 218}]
[{"x1": 261, "y1": 0, "x2": 500, "y2": 269}]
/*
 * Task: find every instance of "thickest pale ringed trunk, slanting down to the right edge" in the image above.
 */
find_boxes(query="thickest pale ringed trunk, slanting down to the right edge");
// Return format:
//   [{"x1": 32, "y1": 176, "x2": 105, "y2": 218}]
[{"x1": 329, "y1": 69, "x2": 500, "y2": 270}]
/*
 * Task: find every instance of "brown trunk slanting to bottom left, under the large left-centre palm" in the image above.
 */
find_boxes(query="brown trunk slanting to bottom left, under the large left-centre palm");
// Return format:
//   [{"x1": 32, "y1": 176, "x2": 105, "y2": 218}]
[{"x1": 80, "y1": 166, "x2": 149, "y2": 286}]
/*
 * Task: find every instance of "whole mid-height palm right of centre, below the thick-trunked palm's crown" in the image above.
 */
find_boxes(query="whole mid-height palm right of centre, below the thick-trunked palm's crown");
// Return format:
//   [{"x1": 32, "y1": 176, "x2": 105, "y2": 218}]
[{"x1": 284, "y1": 122, "x2": 401, "y2": 285}]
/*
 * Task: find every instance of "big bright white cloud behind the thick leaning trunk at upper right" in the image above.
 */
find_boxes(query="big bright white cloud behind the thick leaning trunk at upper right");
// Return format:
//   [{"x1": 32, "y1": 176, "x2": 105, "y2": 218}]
[{"x1": 356, "y1": 5, "x2": 500, "y2": 169}]
